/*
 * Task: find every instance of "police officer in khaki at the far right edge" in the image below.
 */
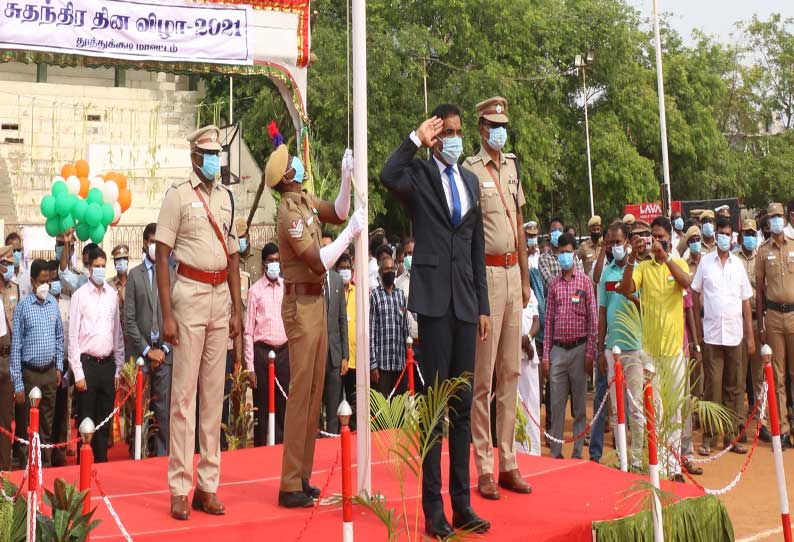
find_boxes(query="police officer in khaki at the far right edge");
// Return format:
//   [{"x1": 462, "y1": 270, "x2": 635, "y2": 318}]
[{"x1": 755, "y1": 203, "x2": 794, "y2": 448}]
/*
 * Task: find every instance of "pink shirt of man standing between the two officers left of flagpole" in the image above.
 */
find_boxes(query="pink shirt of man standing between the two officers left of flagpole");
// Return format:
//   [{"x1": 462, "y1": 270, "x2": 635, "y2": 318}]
[{"x1": 243, "y1": 276, "x2": 287, "y2": 372}]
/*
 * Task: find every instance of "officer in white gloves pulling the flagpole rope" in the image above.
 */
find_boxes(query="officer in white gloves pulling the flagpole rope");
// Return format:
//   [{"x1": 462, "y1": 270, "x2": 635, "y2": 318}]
[{"x1": 265, "y1": 129, "x2": 366, "y2": 508}]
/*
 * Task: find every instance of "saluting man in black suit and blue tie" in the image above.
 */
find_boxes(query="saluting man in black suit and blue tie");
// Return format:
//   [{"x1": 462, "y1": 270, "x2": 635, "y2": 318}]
[{"x1": 381, "y1": 104, "x2": 490, "y2": 538}]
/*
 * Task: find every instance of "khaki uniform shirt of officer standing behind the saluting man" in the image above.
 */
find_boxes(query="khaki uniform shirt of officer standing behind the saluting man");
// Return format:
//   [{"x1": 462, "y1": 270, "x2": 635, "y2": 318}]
[{"x1": 463, "y1": 147, "x2": 525, "y2": 256}]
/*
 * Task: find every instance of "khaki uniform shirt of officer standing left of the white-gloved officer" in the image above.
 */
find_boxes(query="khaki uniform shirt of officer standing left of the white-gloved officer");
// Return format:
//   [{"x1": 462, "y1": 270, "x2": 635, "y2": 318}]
[{"x1": 155, "y1": 172, "x2": 240, "y2": 272}]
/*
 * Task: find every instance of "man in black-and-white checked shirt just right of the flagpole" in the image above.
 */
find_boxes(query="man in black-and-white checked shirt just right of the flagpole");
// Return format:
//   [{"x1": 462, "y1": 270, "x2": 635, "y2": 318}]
[{"x1": 369, "y1": 255, "x2": 408, "y2": 396}]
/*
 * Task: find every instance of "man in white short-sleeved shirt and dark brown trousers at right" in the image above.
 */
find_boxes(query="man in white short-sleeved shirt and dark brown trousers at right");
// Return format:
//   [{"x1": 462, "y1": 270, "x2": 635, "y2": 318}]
[{"x1": 692, "y1": 217, "x2": 755, "y2": 455}]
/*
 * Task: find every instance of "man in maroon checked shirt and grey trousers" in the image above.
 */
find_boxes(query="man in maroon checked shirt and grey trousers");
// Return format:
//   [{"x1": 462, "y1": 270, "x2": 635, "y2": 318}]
[{"x1": 543, "y1": 233, "x2": 598, "y2": 459}]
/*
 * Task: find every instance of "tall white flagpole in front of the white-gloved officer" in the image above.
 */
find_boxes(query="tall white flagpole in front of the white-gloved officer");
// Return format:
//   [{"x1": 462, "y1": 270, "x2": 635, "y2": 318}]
[{"x1": 353, "y1": 0, "x2": 372, "y2": 495}]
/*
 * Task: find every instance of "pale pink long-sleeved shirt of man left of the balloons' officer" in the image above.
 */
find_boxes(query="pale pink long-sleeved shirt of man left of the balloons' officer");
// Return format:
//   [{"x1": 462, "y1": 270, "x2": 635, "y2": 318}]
[{"x1": 68, "y1": 281, "x2": 124, "y2": 382}]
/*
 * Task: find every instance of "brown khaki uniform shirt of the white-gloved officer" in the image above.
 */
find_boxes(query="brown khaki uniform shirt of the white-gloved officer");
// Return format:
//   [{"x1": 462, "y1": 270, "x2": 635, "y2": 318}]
[{"x1": 278, "y1": 190, "x2": 324, "y2": 284}]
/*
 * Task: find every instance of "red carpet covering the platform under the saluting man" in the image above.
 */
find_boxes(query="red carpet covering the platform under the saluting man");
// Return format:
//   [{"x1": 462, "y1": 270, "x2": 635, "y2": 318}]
[{"x1": 14, "y1": 439, "x2": 702, "y2": 542}]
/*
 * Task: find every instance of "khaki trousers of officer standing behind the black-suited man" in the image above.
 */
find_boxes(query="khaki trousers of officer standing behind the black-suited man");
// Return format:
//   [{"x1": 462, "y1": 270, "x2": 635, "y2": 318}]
[{"x1": 471, "y1": 265, "x2": 523, "y2": 476}]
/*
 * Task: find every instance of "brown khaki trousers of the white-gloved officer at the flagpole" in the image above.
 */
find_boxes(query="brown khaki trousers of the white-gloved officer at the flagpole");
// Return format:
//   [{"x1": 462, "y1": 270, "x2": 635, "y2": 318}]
[{"x1": 280, "y1": 295, "x2": 328, "y2": 492}]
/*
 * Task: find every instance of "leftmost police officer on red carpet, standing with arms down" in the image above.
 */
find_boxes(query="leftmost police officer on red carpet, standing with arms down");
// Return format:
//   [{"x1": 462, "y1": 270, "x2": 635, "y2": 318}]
[{"x1": 155, "y1": 126, "x2": 242, "y2": 520}]
